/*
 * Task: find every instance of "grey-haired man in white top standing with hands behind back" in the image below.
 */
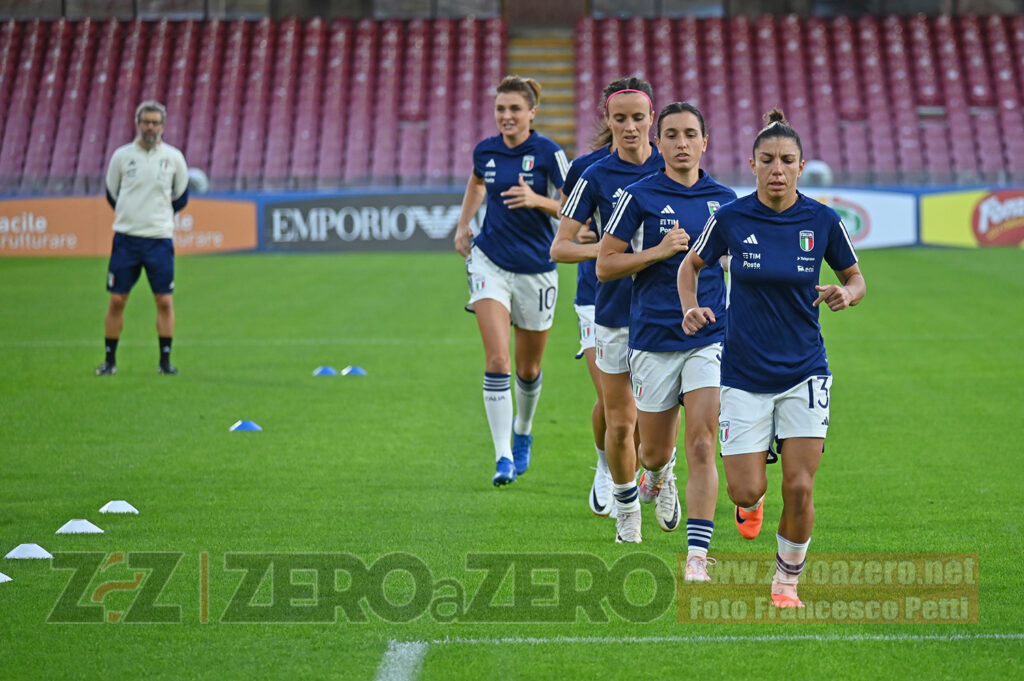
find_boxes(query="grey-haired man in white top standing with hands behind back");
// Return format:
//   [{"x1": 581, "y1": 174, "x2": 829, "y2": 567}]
[{"x1": 96, "y1": 100, "x2": 188, "y2": 376}]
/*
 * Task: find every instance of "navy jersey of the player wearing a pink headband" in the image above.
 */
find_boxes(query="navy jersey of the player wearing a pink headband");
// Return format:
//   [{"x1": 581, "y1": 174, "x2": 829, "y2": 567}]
[{"x1": 562, "y1": 148, "x2": 665, "y2": 328}]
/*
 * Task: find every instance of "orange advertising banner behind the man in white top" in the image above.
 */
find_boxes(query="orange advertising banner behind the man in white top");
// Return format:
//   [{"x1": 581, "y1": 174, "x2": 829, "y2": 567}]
[{"x1": 0, "y1": 197, "x2": 256, "y2": 257}]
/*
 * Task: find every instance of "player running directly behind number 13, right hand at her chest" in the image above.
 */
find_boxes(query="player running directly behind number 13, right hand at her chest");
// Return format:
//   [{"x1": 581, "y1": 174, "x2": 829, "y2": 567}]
[{"x1": 597, "y1": 101, "x2": 736, "y2": 569}]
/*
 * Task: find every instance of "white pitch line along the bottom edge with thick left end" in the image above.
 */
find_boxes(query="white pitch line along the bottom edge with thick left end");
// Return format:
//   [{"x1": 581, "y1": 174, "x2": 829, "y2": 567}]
[{"x1": 374, "y1": 632, "x2": 1024, "y2": 681}]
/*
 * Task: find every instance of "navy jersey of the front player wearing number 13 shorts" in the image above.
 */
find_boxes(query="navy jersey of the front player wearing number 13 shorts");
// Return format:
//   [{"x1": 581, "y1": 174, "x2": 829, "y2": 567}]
[{"x1": 693, "y1": 194, "x2": 857, "y2": 393}]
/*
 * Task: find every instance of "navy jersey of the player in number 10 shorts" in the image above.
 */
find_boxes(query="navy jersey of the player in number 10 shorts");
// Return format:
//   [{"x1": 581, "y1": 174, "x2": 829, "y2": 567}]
[{"x1": 473, "y1": 130, "x2": 569, "y2": 274}]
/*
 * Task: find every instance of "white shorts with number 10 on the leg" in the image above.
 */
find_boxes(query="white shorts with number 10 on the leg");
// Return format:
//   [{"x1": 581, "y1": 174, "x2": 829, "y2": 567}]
[{"x1": 466, "y1": 246, "x2": 558, "y2": 331}]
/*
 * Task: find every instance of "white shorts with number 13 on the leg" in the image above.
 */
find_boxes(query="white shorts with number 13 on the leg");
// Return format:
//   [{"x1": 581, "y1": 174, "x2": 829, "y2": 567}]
[{"x1": 718, "y1": 376, "x2": 833, "y2": 457}]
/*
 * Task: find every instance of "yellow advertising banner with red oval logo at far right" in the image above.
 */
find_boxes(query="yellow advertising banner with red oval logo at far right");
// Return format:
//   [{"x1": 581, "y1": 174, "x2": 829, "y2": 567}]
[{"x1": 921, "y1": 189, "x2": 1024, "y2": 248}]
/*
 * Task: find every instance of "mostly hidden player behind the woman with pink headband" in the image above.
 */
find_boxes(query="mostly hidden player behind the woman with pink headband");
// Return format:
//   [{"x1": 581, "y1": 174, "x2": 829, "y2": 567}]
[{"x1": 562, "y1": 119, "x2": 617, "y2": 516}]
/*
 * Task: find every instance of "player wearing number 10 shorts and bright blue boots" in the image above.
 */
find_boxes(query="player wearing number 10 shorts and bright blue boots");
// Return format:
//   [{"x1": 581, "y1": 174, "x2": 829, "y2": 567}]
[{"x1": 455, "y1": 76, "x2": 568, "y2": 485}]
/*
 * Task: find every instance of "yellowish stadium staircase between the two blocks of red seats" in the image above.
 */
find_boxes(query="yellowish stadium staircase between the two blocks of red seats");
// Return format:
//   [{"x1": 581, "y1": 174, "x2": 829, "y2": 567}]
[{"x1": 507, "y1": 29, "x2": 577, "y2": 159}]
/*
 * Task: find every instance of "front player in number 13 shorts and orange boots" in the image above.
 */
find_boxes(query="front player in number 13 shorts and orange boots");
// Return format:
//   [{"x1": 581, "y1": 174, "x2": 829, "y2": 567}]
[{"x1": 679, "y1": 109, "x2": 865, "y2": 607}]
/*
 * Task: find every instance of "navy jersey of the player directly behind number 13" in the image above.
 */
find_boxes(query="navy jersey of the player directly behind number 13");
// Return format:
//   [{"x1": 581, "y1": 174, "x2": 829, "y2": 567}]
[{"x1": 605, "y1": 170, "x2": 736, "y2": 352}]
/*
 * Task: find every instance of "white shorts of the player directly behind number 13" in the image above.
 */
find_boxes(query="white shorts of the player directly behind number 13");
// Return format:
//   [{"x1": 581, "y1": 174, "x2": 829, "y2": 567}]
[{"x1": 630, "y1": 343, "x2": 722, "y2": 413}]
